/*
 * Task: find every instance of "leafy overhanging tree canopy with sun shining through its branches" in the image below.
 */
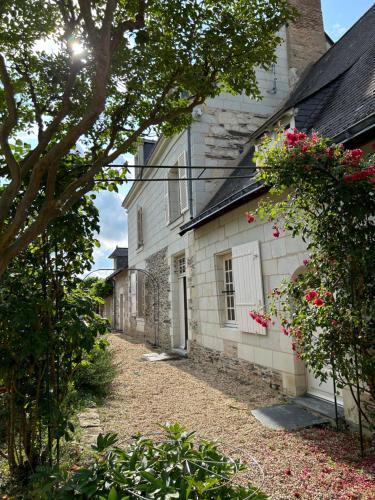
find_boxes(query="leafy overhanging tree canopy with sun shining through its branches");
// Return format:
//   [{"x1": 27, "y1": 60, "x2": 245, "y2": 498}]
[{"x1": 0, "y1": 0, "x2": 295, "y2": 274}]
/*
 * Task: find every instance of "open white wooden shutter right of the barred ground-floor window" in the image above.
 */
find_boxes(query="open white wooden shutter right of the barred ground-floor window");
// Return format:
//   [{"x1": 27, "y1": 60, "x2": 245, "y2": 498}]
[{"x1": 232, "y1": 241, "x2": 267, "y2": 335}]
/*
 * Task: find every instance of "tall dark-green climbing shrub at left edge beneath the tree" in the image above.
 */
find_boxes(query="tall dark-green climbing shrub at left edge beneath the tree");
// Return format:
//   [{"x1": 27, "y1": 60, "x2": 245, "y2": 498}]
[{"x1": 0, "y1": 193, "x2": 107, "y2": 475}]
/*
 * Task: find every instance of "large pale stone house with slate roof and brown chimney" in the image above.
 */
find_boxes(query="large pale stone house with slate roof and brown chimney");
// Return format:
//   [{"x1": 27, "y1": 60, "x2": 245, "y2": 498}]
[{"x1": 123, "y1": 0, "x2": 375, "y2": 422}]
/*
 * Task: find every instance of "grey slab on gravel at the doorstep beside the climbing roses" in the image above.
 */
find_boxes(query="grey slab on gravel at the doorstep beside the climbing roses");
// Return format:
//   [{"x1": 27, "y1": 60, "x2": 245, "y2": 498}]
[{"x1": 251, "y1": 404, "x2": 329, "y2": 431}]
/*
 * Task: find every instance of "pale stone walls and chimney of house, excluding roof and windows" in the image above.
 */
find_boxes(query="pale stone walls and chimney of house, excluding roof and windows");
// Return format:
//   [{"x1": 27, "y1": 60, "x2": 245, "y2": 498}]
[{"x1": 123, "y1": 0, "x2": 326, "y2": 406}]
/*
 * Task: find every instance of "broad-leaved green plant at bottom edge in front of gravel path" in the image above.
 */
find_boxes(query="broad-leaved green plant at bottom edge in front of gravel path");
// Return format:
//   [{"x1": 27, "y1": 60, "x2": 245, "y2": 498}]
[{"x1": 51, "y1": 424, "x2": 267, "y2": 500}]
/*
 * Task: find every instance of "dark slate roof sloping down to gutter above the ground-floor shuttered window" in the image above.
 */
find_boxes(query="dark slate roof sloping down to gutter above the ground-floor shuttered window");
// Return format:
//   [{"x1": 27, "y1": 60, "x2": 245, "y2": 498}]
[{"x1": 180, "y1": 5, "x2": 375, "y2": 234}]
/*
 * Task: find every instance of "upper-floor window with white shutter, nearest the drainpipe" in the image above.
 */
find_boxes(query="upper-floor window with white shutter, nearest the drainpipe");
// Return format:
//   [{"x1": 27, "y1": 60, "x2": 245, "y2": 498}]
[{"x1": 165, "y1": 152, "x2": 189, "y2": 224}]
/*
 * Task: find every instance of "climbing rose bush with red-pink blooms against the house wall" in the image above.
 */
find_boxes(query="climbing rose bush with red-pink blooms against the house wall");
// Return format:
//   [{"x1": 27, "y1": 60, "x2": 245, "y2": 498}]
[{"x1": 254, "y1": 129, "x2": 375, "y2": 423}]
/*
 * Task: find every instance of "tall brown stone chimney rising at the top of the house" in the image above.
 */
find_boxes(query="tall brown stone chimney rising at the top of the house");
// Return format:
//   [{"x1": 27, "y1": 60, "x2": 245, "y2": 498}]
[{"x1": 286, "y1": 0, "x2": 327, "y2": 88}]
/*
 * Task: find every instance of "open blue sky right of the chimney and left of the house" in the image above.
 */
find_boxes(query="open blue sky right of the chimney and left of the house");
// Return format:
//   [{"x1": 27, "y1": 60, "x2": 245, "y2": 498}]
[{"x1": 93, "y1": 0, "x2": 374, "y2": 274}]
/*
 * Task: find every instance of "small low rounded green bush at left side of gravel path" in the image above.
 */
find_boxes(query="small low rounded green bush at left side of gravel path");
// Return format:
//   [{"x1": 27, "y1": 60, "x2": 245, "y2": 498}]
[{"x1": 74, "y1": 339, "x2": 116, "y2": 398}]
